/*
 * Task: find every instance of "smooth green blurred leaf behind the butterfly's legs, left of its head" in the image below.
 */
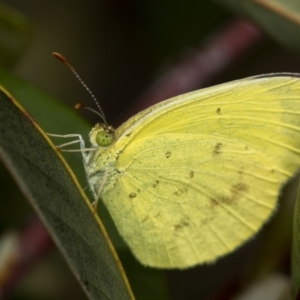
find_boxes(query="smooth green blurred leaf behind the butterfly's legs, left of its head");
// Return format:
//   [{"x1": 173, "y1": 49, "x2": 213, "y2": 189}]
[{"x1": 0, "y1": 69, "x2": 91, "y2": 186}]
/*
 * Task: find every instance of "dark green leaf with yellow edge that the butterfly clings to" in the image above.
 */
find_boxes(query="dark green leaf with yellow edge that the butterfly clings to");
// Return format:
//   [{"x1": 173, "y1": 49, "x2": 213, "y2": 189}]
[{"x1": 0, "y1": 83, "x2": 133, "y2": 299}]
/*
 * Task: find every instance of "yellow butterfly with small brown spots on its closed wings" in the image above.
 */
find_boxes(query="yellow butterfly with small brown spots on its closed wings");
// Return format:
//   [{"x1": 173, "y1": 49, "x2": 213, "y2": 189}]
[{"x1": 50, "y1": 52, "x2": 300, "y2": 268}]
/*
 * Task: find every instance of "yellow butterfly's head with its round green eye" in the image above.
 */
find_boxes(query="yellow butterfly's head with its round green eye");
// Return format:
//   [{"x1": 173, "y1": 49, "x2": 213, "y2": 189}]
[{"x1": 89, "y1": 123, "x2": 115, "y2": 147}]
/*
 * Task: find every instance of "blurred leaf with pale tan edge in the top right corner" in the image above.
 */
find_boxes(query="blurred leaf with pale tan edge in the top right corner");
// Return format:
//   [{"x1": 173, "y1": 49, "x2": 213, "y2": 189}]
[{"x1": 217, "y1": 0, "x2": 300, "y2": 52}]
